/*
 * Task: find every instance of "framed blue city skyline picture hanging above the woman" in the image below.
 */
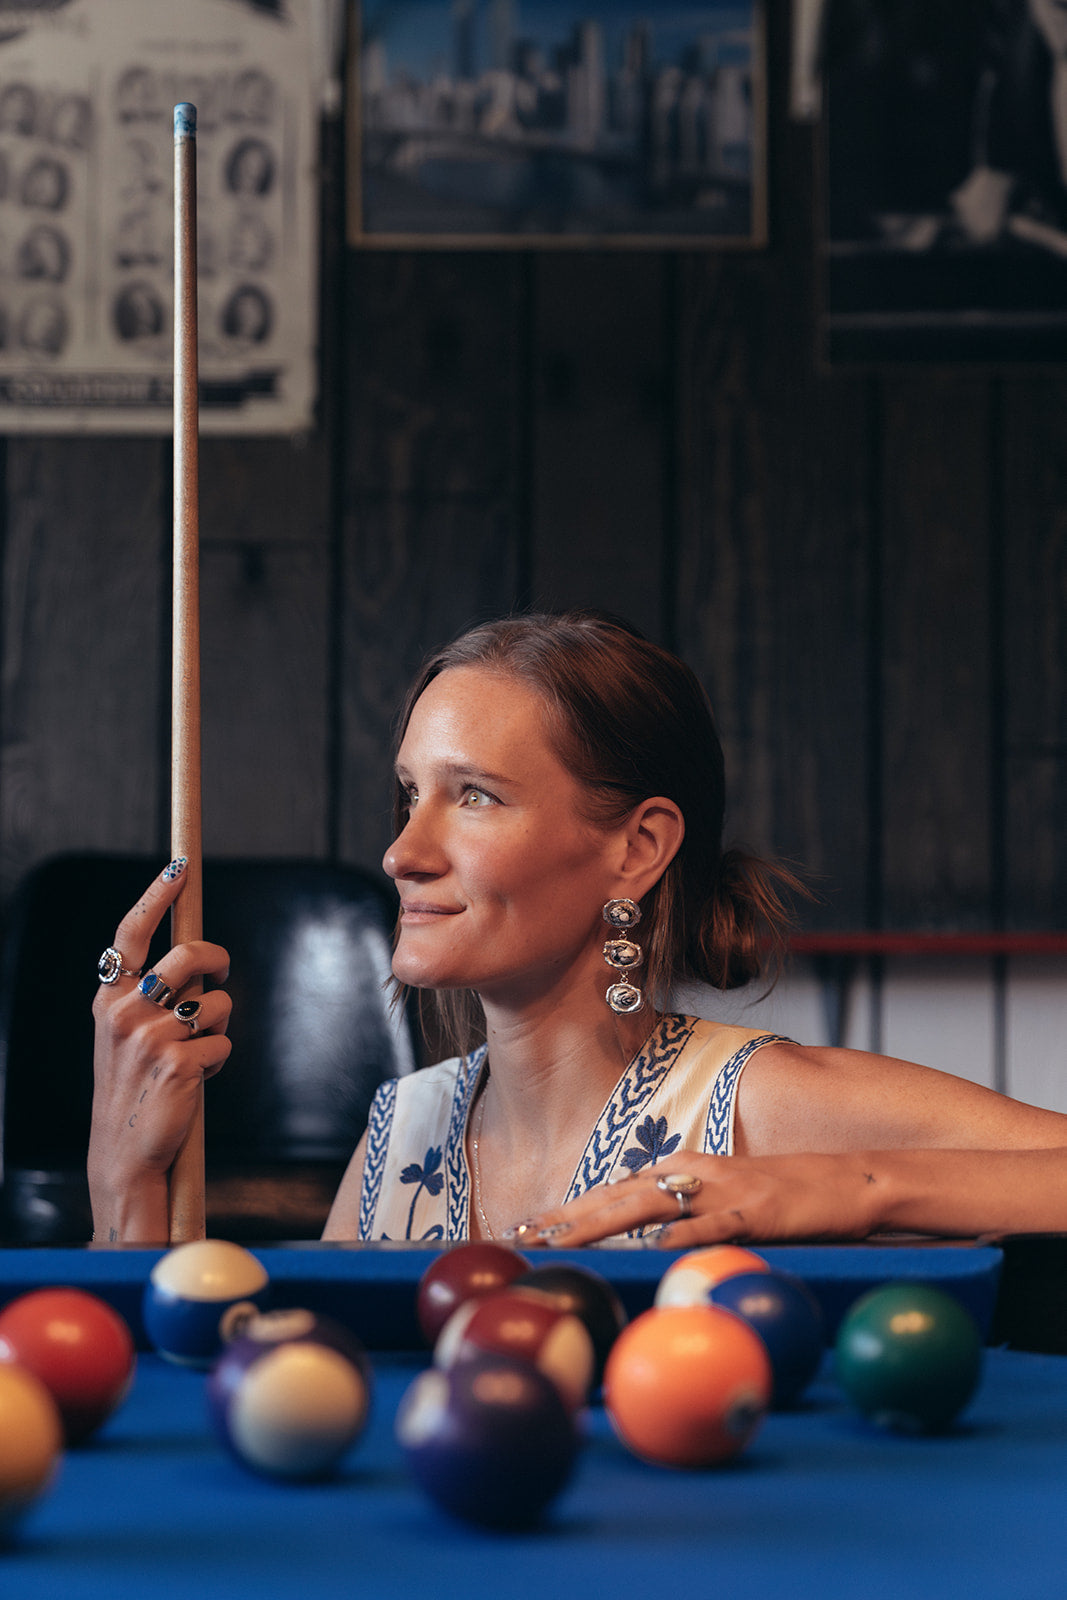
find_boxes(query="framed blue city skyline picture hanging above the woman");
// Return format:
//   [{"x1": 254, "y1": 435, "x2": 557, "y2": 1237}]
[{"x1": 347, "y1": 0, "x2": 766, "y2": 250}]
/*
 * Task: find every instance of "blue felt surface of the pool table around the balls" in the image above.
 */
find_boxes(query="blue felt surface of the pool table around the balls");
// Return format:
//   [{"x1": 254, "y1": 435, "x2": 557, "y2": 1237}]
[{"x1": 0, "y1": 1245, "x2": 1067, "y2": 1600}]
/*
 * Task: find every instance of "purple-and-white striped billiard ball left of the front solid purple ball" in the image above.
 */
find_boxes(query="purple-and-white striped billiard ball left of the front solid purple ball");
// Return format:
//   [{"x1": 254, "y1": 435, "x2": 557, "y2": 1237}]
[{"x1": 208, "y1": 1309, "x2": 371, "y2": 1480}]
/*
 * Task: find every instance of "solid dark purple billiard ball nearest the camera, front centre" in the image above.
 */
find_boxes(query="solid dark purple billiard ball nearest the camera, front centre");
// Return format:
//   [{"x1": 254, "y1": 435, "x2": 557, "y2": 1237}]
[{"x1": 397, "y1": 1355, "x2": 579, "y2": 1528}]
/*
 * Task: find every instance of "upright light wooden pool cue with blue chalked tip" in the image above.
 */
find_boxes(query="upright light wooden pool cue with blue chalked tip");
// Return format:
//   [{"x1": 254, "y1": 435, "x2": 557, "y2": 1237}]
[{"x1": 170, "y1": 102, "x2": 206, "y2": 1245}]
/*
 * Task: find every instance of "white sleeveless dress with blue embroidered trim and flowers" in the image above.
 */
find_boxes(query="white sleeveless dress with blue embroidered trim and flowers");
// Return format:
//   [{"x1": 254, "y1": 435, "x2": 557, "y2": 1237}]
[{"x1": 358, "y1": 1016, "x2": 784, "y2": 1242}]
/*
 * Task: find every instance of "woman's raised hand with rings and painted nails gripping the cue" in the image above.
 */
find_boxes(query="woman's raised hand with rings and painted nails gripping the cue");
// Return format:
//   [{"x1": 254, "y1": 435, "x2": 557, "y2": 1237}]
[{"x1": 88, "y1": 861, "x2": 230, "y2": 1243}]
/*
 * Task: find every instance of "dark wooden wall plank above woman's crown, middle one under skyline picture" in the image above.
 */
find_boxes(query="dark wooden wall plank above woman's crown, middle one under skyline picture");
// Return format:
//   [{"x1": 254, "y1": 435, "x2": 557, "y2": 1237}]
[{"x1": 530, "y1": 253, "x2": 672, "y2": 638}]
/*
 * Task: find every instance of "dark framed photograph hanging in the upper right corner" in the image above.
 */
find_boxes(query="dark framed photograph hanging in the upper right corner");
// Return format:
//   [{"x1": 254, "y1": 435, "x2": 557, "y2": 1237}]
[{"x1": 821, "y1": 0, "x2": 1067, "y2": 365}]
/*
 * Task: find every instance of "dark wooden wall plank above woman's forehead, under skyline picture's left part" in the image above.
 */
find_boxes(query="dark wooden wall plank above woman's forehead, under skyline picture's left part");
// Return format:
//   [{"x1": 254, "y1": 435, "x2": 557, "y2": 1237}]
[{"x1": 336, "y1": 254, "x2": 525, "y2": 869}]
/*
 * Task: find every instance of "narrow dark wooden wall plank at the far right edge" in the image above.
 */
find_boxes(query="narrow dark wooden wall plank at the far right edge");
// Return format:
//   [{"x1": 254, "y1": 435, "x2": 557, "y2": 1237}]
[{"x1": 1003, "y1": 373, "x2": 1067, "y2": 928}]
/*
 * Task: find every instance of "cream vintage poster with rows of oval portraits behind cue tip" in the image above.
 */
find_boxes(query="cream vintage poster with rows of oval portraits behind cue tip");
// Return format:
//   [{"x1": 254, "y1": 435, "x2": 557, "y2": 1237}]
[{"x1": 0, "y1": 0, "x2": 320, "y2": 434}]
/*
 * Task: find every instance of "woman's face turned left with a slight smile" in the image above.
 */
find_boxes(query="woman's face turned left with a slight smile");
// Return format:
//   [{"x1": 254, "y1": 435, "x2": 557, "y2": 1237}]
[{"x1": 384, "y1": 667, "x2": 625, "y2": 1005}]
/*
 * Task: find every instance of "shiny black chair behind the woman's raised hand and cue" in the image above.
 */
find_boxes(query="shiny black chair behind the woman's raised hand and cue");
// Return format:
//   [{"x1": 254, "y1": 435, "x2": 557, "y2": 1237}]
[{"x1": 0, "y1": 856, "x2": 418, "y2": 1245}]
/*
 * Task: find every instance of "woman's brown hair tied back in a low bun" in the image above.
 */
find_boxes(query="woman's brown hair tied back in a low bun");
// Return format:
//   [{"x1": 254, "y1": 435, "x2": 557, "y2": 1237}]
[{"x1": 394, "y1": 611, "x2": 805, "y2": 1051}]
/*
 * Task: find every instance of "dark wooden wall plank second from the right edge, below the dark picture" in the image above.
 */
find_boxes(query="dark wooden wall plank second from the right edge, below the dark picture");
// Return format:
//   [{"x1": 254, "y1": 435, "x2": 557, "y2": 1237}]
[{"x1": 880, "y1": 374, "x2": 995, "y2": 928}]
